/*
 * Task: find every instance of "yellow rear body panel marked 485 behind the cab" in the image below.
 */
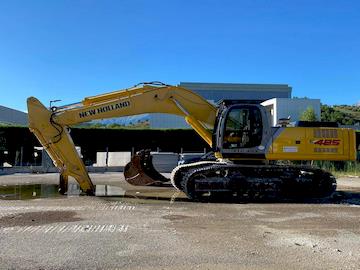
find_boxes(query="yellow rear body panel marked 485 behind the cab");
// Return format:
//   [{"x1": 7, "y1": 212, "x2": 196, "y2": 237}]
[{"x1": 266, "y1": 127, "x2": 356, "y2": 160}]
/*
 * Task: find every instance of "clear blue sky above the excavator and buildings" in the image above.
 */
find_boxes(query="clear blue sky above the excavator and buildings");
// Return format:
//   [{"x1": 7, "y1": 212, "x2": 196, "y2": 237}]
[{"x1": 0, "y1": 0, "x2": 360, "y2": 111}]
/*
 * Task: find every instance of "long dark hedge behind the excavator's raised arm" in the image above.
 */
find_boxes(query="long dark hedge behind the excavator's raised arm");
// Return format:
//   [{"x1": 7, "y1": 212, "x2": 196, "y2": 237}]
[{"x1": 0, "y1": 127, "x2": 210, "y2": 170}]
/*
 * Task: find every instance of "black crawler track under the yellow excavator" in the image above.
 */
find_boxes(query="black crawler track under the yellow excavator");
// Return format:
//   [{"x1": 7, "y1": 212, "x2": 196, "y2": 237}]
[{"x1": 171, "y1": 162, "x2": 336, "y2": 200}]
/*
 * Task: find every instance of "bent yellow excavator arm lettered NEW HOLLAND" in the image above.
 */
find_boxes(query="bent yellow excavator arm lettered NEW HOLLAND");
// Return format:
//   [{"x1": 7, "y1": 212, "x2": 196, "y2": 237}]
[{"x1": 27, "y1": 82, "x2": 217, "y2": 194}]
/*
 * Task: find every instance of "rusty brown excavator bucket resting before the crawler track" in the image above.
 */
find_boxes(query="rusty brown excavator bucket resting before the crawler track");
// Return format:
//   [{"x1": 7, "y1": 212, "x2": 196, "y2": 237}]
[{"x1": 124, "y1": 150, "x2": 170, "y2": 186}]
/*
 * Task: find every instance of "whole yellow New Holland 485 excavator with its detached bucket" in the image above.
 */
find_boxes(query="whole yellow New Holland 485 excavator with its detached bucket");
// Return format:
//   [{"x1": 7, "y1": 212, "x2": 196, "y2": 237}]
[{"x1": 27, "y1": 82, "x2": 356, "y2": 200}]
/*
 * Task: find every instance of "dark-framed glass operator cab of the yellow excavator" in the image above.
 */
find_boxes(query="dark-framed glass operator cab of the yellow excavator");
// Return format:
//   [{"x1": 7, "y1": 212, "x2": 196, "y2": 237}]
[{"x1": 213, "y1": 100, "x2": 270, "y2": 159}]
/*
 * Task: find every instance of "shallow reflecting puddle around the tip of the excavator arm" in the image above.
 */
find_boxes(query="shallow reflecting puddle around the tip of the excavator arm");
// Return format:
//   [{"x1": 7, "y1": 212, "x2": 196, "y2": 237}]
[{"x1": 0, "y1": 183, "x2": 188, "y2": 202}]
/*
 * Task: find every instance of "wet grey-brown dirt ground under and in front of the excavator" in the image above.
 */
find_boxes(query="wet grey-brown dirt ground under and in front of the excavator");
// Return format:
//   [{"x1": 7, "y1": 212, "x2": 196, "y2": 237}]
[{"x1": 0, "y1": 173, "x2": 360, "y2": 269}]
